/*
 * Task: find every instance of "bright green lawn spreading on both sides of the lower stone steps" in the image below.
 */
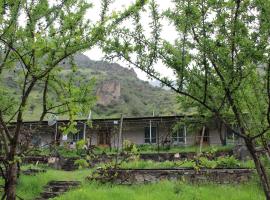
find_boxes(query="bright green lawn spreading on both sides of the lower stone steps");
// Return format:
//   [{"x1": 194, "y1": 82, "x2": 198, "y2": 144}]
[{"x1": 0, "y1": 169, "x2": 264, "y2": 200}]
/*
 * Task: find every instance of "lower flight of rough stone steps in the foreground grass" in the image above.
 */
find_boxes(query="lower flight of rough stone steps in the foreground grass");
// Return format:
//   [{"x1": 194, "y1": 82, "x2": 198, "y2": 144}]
[{"x1": 36, "y1": 181, "x2": 81, "y2": 200}]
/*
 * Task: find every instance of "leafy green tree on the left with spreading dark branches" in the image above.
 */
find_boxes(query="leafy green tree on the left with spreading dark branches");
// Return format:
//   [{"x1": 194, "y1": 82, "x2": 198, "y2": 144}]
[{"x1": 0, "y1": 0, "x2": 145, "y2": 200}]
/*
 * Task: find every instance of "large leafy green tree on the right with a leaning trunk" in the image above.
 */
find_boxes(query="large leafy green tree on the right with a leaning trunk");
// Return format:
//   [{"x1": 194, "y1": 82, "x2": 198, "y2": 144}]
[{"x1": 100, "y1": 0, "x2": 270, "y2": 199}]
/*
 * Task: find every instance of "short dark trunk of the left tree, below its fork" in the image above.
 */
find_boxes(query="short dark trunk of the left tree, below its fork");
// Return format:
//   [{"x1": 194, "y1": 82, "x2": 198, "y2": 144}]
[{"x1": 6, "y1": 162, "x2": 17, "y2": 200}]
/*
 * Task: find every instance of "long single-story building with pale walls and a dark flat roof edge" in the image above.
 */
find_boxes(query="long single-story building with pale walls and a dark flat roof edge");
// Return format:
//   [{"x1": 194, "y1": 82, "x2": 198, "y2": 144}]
[{"x1": 4, "y1": 116, "x2": 241, "y2": 147}]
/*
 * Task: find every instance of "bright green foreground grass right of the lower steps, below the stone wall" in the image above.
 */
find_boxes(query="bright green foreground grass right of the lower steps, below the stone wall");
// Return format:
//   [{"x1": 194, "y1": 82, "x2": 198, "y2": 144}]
[{"x1": 56, "y1": 181, "x2": 264, "y2": 200}]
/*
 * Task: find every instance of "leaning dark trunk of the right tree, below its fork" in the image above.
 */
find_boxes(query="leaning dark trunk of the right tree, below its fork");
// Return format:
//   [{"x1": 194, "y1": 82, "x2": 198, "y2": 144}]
[{"x1": 245, "y1": 138, "x2": 270, "y2": 200}]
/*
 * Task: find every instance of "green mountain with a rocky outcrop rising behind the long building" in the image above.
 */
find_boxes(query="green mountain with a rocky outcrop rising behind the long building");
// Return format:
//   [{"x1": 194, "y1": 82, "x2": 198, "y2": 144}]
[{"x1": 3, "y1": 54, "x2": 178, "y2": 120}]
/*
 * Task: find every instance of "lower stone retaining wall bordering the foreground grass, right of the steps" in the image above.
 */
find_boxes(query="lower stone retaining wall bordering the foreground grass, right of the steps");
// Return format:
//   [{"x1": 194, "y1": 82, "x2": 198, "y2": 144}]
[{"x1": 113, "y1": 168, "x2": 254, "y2": 184}]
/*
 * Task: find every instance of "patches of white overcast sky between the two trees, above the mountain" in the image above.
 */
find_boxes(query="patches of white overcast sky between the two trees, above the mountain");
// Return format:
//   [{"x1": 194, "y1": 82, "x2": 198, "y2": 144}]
[{"x1": 84, "y1": 0, "x2": 177, "y2": 80}]
